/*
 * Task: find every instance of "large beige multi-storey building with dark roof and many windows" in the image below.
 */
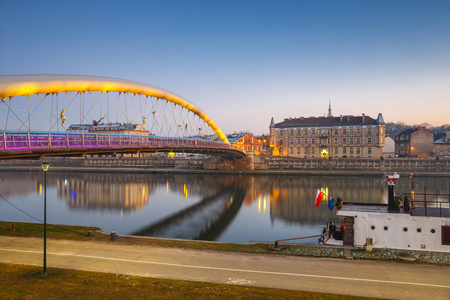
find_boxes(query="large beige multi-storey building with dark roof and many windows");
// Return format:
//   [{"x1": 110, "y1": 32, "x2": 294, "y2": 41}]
[{"x1": 270, "y1": 113, "x2": 385, "y2": 158}]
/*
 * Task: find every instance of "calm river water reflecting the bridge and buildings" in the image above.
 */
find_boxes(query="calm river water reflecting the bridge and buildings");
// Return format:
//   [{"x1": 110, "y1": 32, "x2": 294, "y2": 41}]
[{"x1": 0, "y1": 171, "x2": 450, "y2": 243}]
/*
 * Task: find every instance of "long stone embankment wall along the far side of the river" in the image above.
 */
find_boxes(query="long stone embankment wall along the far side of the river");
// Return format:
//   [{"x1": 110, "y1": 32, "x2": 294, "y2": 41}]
[{"x1": 0, "y1": 154, "x2": 450, "y2": 172}]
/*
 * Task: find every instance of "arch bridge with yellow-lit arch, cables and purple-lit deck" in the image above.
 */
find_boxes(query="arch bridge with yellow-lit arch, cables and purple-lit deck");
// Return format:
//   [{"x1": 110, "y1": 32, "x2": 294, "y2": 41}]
[{"x1": 0, "y1": 75, "x2": 245, "y2": 159}]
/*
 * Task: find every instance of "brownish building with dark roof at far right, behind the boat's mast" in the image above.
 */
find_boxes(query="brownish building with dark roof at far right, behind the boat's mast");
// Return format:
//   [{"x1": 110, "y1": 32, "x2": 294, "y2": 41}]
[{"x1": 395, "y1": 127, "x2": 434, "y2": 157}]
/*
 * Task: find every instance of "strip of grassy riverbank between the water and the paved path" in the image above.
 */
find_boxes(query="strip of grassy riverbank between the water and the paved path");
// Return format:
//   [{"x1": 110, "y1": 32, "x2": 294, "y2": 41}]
[{"x1": 0, "y1": 222, "x2": 450, "y2": 266}]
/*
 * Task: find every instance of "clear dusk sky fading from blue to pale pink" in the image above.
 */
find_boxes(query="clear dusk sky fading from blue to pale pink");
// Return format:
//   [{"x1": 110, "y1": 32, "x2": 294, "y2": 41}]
[{"x1": 0, "y1": 0, "x2": 450, "y2": 134}]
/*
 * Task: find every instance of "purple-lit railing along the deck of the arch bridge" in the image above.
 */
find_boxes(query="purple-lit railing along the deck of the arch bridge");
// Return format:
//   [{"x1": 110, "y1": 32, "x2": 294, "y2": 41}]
[{"x1": 0, "y1": 131, "x2": 242, "y2": 153}]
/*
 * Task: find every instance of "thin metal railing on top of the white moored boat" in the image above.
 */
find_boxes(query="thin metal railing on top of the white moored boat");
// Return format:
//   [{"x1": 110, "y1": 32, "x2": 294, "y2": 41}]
[{"x1": 402, "y1": 192, "x2": 450, "y2": 217}]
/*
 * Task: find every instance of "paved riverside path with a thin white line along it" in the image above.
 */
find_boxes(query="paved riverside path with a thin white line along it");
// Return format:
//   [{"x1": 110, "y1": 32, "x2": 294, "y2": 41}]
[{"x1": 0, "y1": 236, "x2": 450, "y2": 300}]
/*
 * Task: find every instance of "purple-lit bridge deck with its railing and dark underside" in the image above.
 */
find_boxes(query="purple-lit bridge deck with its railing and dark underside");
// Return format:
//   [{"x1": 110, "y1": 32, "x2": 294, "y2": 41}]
[{"x1": 0, "y1": 132, "x2": 245, "y2": 159}]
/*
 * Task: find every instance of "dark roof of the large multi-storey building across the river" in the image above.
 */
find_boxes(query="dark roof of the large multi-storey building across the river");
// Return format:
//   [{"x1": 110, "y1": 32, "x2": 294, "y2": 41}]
[{"x1": 271, "y1": 114, "x2": 384, "y2": 128}]
